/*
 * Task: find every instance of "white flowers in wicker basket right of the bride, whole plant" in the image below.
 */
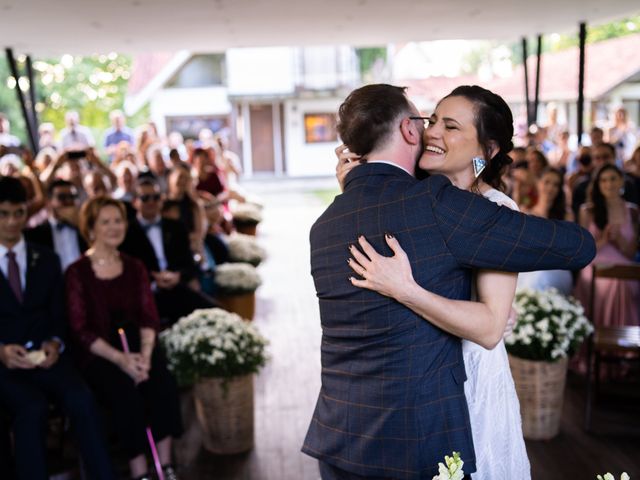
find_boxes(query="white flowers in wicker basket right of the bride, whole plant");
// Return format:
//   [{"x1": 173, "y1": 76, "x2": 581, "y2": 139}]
[{"x1": 505, "y1": 288, "x2": 593, "y2": 440}]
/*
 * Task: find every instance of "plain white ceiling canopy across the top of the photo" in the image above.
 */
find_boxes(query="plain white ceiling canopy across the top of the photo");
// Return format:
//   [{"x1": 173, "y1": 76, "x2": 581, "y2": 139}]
[{"x1": 0, "y1": 0, "x2": 638, "y2": 56}]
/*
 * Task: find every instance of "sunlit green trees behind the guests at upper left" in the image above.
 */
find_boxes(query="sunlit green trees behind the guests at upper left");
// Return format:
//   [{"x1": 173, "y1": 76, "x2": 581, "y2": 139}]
[{"x1": 0, "y1": 53, "x2": 148, "y2": 150}]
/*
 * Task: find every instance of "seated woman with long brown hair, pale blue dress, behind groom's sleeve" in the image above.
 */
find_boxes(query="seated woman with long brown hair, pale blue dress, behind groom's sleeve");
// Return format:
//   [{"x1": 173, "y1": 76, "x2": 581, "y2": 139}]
[{"x1": 518, "y1": 167, "x2": 573, "y2": 295}]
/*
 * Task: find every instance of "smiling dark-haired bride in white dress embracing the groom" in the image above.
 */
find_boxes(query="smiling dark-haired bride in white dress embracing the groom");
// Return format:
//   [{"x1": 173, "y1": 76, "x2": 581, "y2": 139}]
[{"x1": 336, "y1": 86, "x2": 531, "y2": 480}]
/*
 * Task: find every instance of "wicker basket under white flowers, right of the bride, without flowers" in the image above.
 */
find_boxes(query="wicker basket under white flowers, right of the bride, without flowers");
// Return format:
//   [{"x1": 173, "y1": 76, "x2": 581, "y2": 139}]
[{"x1": 509, "y1": 355, "x2": 568, "y2": 440}]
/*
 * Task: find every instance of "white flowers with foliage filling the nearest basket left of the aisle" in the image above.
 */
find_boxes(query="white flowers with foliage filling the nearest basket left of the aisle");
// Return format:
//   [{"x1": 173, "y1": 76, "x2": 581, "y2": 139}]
[{"x1": 160, "y1": 308, "x2": 268, "y2": 386}]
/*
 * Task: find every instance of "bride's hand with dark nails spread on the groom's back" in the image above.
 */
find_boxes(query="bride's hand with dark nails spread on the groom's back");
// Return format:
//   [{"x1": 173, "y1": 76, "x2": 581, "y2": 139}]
[{"x1": 347, "y1": 233, "x2": 415, "y2": 300}]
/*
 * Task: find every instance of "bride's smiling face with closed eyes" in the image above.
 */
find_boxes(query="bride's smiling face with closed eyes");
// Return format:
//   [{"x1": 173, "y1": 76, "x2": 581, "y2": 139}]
[{"x1": 419, "y1": 97, "x2": 484, "y2": 179}]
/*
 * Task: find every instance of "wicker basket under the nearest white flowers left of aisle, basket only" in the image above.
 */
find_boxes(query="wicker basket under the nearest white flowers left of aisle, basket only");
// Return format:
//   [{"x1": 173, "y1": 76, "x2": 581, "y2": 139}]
[{"x1": 194, "y1": 374, "x2": 254, "y2": 455}]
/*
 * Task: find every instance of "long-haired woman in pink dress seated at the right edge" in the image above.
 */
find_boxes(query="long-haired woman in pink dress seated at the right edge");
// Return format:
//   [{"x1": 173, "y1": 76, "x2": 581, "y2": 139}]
[{"x1": 576, "y1": 164, "x2": 640, "y2": 326}]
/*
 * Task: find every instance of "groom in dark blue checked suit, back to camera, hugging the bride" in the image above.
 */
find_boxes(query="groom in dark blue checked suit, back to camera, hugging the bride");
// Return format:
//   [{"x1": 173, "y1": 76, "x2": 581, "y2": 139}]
[{"x1": 302, "y1": 85, "x2": 595, "y2": 480}]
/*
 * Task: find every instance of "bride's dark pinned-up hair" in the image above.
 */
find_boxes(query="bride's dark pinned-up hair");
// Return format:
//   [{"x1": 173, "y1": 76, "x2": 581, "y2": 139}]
[{"x1": 440, "y1": 85, "x2": 513, "y2": 191}]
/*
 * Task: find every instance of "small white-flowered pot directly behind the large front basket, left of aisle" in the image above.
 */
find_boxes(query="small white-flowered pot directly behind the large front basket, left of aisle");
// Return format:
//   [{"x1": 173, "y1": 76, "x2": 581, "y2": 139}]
[{"x1": 214, "y1": 263, "x2": 262, "y2": 320}]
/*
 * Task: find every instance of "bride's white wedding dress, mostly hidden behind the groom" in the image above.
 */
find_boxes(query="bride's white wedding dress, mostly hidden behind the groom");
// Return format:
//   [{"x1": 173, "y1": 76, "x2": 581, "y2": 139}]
[{"x1": 462, "y1": 189, "x2": 531, "y2": 480}]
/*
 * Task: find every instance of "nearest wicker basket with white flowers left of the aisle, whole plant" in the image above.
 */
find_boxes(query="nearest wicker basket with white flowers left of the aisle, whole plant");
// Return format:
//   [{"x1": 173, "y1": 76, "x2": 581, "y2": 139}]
[{"x1": 160, "y1": 308, "x2": 268, "y2": 454}]
